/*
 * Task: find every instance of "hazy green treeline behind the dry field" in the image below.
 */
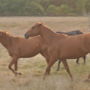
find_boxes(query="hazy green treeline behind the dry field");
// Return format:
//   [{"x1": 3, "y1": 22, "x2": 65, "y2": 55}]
[{"x1": 0, "y1": 0, "x2": 90, "y2": 16}]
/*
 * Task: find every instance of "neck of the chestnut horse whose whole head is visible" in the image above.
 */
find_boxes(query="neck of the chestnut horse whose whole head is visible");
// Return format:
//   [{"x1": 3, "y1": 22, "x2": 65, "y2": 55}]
[{"x1": 40, "y1": 27, "x2": 56, "y2": 43}]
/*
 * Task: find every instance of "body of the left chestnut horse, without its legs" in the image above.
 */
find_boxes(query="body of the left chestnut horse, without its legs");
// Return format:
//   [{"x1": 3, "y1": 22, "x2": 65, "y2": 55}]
[{"x1": 0, "y1": 35, "x2": 41, "y2": 58}]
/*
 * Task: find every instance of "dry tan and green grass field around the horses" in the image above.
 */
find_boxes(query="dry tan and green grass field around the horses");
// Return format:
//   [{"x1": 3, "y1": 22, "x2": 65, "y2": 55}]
[{"x1": 0, "y1": 17, "x2": 90, "y2": 90}]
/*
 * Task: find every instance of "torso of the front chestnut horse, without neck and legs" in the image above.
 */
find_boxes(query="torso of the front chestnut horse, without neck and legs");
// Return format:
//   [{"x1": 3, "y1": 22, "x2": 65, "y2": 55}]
[{"x1": 42, "y1": 35, "x2": 89, "y2": 59}]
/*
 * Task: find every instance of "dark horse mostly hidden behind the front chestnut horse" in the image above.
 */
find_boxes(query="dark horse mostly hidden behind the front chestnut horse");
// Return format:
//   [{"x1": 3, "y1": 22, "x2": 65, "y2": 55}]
[{"x1": 56, "y1": 30, "x2": 86, "y2": 71}]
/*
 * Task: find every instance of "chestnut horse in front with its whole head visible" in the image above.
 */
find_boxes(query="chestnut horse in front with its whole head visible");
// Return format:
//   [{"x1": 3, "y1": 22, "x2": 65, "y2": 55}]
[{"x1": 25, "y1": 23, "x2": 90, "y2": 79}]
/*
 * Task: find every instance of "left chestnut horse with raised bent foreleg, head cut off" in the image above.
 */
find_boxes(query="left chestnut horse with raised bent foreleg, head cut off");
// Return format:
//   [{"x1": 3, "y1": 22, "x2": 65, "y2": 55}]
[{"x1": 0, "y1": 31, "x2": 65, "y2": 75}]
